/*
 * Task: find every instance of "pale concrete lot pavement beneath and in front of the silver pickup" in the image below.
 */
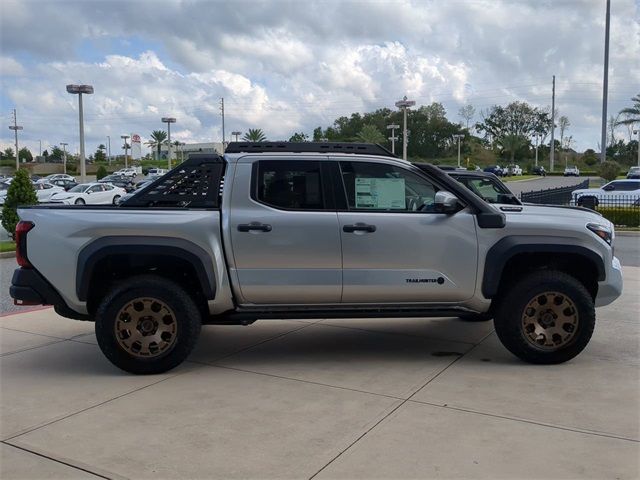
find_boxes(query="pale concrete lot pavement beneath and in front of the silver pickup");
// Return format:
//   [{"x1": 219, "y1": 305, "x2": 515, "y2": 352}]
[{"x1": 0, "y1": 256, "x2": 640, "y2": 478}]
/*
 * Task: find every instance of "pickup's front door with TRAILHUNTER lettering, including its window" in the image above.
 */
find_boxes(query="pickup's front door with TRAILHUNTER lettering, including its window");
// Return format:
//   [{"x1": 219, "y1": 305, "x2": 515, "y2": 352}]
[{"x1": 338, "y1": 160, "x2": 478, "y2": 304}]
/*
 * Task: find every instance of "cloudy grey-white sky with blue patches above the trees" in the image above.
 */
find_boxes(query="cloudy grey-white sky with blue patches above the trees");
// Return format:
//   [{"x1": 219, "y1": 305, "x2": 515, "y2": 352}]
[{"x1": 0, "y1": 0, "x2": 640, "y2": 154}]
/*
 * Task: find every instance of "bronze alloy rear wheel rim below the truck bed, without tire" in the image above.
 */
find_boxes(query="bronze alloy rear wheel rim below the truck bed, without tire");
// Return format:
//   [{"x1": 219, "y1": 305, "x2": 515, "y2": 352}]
[{"x1": 114, "y1": 297, "x2": 178, "y2": 358}]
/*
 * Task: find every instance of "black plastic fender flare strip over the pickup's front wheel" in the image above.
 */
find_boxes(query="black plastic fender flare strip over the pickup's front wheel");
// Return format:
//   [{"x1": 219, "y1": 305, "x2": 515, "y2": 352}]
[{"x1": 482, "y1": 235, "x2": 606, "y2": 298}]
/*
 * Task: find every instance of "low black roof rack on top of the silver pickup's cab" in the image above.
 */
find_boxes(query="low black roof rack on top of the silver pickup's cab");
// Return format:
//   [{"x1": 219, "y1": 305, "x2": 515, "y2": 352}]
[{"x1": 225, "y1": 142, "x2": 396, "y2": 158}]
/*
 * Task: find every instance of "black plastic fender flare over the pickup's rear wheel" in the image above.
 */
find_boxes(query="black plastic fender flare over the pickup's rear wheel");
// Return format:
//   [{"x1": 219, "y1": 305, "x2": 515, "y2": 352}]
[{"x1": 76, "y1": 236, "x2": 216, "y2": 301}]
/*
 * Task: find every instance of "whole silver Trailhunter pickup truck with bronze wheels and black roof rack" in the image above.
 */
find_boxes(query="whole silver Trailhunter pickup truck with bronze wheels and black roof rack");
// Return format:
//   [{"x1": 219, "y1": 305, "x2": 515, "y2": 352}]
[{"x1": 10, "y1": 143, "x2": 622, "y2": 374}]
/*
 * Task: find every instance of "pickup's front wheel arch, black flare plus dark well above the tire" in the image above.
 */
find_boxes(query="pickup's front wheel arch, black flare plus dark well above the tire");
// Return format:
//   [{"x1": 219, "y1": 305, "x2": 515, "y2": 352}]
[{"x1": 482, "y1": 236, "x2": 606, "y2": 298}]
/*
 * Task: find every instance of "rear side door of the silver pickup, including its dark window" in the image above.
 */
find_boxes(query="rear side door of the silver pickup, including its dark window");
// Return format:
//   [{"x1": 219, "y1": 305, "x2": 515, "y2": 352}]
[{"x1": 229, "y1": 156, "x2": 342, "y2": 305}]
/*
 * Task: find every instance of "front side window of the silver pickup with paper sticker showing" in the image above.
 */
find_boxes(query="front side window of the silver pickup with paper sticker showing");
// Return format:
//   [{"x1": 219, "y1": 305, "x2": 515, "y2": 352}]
[{"x1": 340, "y1": 162, "x2": 438, "y2": 212}]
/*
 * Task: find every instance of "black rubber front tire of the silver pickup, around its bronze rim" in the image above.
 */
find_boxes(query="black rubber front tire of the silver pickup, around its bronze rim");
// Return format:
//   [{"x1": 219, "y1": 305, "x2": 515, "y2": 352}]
[{"x1": 494, "y1": 270, "x2": 596, "y2": 364}]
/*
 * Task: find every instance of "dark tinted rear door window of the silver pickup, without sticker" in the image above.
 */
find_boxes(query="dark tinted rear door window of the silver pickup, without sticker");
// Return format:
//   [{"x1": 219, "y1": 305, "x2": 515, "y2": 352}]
[{"x1": 255, "y1": 160, "x2": 324, "y2": 210}]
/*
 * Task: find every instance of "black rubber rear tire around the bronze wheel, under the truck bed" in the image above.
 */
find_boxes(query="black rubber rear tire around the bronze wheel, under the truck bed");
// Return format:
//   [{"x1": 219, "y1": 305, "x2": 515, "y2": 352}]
[{"x1": 95, "y1": 275, "x2": 202, "y2": 375}]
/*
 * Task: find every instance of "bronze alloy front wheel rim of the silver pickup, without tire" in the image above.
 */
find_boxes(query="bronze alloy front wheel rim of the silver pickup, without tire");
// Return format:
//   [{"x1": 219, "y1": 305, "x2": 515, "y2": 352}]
[{"x1": 522, "y1": 292, "x2": 579, "y2": 351}]
